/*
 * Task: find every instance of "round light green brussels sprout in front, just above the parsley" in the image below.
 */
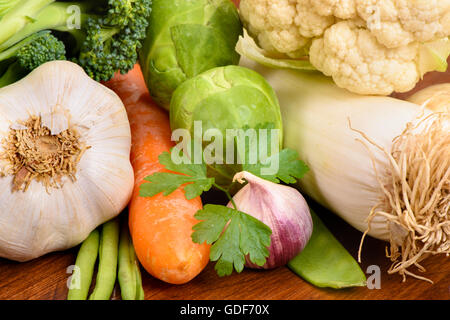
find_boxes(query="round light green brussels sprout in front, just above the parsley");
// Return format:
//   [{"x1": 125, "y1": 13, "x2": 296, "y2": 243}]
[{"x1": 170, "y1": 66, "x2": 283, "y2": 192}]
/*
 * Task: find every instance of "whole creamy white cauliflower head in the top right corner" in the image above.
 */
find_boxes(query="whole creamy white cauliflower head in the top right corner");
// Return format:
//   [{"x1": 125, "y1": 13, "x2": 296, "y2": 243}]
[{"x1": 240, "y1": 0, "x2": 450, "y2": 95}]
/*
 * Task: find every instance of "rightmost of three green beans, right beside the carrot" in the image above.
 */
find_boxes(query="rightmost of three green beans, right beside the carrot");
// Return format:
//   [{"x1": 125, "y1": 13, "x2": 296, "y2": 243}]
[{"x1": 118, "y1": 219, "x2": 144, "y2": 300}]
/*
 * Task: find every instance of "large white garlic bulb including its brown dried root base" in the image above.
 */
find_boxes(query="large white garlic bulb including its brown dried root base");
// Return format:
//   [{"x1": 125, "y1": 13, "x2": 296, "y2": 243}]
[{"x1": 0, "y1": 61, "x2": 134, "y2": 261}]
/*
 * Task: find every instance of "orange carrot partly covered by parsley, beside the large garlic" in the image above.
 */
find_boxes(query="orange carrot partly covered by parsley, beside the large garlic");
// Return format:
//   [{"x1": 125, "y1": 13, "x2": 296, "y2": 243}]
[{"x1": 105, "y1": 65, "x2": 210, "y2": 284}]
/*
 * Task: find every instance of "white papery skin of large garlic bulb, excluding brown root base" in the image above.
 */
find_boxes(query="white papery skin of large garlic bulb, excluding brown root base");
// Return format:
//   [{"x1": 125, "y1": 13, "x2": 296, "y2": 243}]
[{"x1": 0, "y1": 61, "x2": 134, "y2": 261}]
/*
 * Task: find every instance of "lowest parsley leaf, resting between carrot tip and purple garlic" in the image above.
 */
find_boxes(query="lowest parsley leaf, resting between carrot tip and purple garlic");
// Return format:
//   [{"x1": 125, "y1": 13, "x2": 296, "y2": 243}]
[{"x1": 192, "y1": 204, "x2": 272, "y2": 276}]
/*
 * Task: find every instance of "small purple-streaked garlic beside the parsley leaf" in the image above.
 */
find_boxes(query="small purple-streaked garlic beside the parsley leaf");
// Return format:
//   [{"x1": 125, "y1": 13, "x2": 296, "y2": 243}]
[{"x1": 228, "y1": 171, "x2": 313, "y2": 269}]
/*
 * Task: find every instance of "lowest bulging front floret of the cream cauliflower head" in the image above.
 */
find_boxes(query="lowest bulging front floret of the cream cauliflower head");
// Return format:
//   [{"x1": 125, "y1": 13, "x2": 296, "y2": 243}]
[{"x1": 310, "y1": 20, "x2": 420, "y2": 95}]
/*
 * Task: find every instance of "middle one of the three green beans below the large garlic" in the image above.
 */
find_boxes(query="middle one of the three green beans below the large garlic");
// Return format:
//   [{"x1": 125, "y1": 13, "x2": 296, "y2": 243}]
[{"x1": 89, "y1": 218, "x2": 120, "y2": 300}]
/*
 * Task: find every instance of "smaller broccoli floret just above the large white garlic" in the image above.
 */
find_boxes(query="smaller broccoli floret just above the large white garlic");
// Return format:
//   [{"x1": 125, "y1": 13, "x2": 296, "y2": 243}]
[{"x1": 0, "y1": 31, "x2": 66, "y2": 88}]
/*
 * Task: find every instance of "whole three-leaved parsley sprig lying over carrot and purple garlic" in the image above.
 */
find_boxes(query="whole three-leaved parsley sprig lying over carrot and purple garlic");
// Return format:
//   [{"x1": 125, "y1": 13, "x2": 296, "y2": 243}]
[{"x1": 140, "y1": 124, "x2": 308, "y2": 276}]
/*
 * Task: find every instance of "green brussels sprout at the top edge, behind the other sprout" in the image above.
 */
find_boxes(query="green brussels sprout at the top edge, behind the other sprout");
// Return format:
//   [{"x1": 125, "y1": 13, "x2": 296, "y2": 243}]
[{"x1": 139, "y1": 0, "x2": 243, "y2": 109}]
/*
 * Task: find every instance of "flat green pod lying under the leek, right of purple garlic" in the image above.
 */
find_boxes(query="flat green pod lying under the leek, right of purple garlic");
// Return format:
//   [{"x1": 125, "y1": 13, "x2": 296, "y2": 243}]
[{"x1": 288, "y1": 210, "x2": 366, "y2": 289}]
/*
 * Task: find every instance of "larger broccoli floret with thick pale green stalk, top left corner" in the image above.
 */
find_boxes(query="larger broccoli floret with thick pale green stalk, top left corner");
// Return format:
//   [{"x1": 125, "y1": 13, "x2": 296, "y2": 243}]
[{"x1": 0, "y1": 0, "x2": 151, "y2": 81}]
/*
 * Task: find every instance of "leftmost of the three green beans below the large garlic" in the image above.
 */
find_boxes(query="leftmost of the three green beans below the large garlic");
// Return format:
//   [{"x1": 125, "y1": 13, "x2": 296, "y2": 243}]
[{"x1": 67, "y1": 230, "x2": 100, "y2": 300}]
